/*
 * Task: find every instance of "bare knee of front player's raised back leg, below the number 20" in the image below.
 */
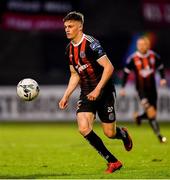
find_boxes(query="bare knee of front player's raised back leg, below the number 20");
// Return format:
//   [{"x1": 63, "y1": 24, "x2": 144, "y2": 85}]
[{"x1": 102, "y1": 121, "x2": 116, "y2": 138}]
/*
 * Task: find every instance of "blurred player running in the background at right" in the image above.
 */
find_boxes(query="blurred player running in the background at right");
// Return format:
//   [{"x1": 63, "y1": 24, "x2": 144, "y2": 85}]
[{"x1": 120, "y1": 36, "x2": 166, "y2": 142}]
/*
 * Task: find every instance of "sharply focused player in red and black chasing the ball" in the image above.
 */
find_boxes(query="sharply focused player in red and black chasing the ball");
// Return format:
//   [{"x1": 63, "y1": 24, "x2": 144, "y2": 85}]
[{"x1": 59, "y1": 11, "x2": 132, "y2": 173}]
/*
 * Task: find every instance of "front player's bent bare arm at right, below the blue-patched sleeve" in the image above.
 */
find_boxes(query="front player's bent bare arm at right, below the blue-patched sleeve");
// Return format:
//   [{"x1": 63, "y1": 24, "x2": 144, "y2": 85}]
[{"x1": 87, "y1": 55, "x2": 114, "y2": 101}]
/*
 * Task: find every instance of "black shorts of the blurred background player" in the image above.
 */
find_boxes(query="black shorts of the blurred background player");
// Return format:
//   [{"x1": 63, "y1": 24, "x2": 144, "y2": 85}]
[{"x1": 138, "y1": 89, "x2": 157, "y2": 109}]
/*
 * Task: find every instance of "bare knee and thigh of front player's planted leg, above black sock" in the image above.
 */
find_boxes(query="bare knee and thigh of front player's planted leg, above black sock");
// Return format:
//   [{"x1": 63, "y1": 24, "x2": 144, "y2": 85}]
[{"x1": 77, "y1": 112, "x2": 95, "y2": 136}]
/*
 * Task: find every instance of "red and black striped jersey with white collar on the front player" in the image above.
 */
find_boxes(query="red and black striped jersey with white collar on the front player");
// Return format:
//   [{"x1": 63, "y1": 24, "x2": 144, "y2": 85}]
[{"x1": 66, "y1": 34, "x2": 114, "y2": 95}]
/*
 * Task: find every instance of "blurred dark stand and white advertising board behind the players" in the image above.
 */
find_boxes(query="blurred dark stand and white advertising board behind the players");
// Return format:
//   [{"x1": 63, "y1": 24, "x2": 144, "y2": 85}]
[{"x1": 0, "y1": 0, "x2": 170, "y2": 120}]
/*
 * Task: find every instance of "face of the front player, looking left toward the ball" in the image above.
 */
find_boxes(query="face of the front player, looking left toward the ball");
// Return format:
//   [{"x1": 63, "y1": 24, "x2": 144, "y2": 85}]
[{"x1": 64, "y1": 20, "x2": 82, "y2": 40}]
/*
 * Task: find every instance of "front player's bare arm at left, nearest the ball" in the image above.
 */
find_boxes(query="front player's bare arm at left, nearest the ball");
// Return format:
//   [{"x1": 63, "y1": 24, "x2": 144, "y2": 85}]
[{"x1": 59, "y1": 65, "x2": 80, "y2": 109}]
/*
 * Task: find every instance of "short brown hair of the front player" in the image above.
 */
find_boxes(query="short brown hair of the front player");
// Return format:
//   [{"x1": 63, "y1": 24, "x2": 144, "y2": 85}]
[{"x1": 63, "y1": 11, "x2": 84, "y2": 24}]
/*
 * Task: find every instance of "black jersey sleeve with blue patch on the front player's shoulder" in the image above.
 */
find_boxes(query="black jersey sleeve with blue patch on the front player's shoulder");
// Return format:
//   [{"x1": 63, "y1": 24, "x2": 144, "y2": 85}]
[{"x1": 89, "y1": 40, "x2": 106, "y2": 61}]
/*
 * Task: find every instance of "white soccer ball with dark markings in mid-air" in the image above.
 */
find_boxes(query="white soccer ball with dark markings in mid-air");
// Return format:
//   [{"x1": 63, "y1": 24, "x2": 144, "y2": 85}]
[{"x1": 17, "y1": 78, "x2": 40, "y2": 101}]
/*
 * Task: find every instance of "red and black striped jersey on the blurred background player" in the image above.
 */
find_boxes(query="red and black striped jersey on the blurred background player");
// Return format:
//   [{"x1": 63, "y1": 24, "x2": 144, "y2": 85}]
[{"x1": 123, "y1": 50, "x2": 164, "y2": 91}]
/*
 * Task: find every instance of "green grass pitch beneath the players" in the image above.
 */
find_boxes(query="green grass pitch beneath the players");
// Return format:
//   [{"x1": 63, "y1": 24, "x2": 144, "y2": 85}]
[{"x1": 0, "y1": 122, "x2": 170, "y2": 179}]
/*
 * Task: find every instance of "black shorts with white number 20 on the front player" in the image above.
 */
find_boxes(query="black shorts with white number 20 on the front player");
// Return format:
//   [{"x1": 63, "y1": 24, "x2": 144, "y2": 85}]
[{"x1": 77, "y1": 92, "x2": 116, "y2": 123}]
